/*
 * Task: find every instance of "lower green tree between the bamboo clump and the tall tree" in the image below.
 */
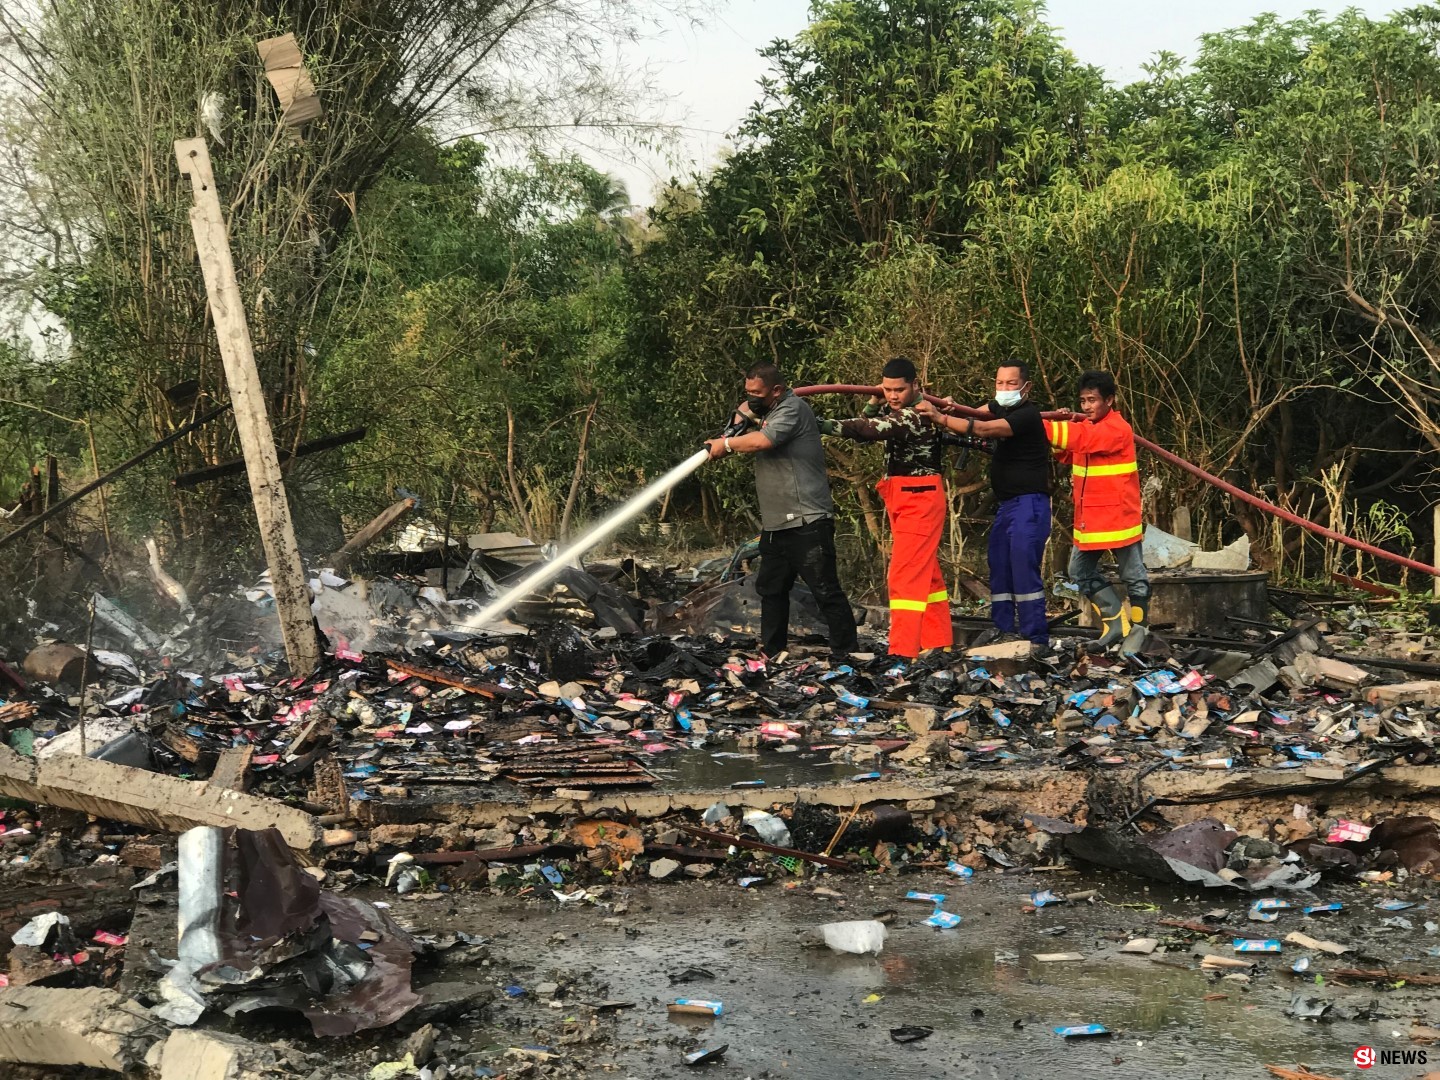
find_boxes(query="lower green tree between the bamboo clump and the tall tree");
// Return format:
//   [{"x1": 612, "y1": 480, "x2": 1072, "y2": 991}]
[{"x1": 320, "y1": 138, "x2": 672, "y2": 537}]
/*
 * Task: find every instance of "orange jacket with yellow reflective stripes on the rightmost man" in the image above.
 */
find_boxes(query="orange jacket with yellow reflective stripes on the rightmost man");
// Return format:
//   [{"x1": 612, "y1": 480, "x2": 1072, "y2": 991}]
[{"x1": 1045, "y1": 409, "x2": 1145, "y2": 552}]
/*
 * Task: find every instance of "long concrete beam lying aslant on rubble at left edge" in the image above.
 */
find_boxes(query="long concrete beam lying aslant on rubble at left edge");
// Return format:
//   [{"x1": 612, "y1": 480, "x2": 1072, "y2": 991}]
[{"x1": 0, "y1": 746, "x2": 321, "y2": 852}]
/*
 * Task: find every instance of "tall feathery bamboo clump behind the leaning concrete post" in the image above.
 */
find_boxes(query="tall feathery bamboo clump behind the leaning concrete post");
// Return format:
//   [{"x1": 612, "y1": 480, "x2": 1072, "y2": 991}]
[{"x1": 0, "y1": 0, "x2": 673, "y2": 558}]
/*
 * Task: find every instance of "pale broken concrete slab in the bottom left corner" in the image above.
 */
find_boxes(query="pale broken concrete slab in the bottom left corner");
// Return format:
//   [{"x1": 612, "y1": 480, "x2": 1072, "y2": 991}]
[{"x1": 0, "y1": 986, "x2": 167, "y2": 1073}]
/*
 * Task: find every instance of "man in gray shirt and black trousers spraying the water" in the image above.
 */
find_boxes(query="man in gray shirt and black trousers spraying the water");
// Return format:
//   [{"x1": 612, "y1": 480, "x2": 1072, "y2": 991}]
[{"x1": 706, "y1": 364, "x2": 858, "y2": 657}]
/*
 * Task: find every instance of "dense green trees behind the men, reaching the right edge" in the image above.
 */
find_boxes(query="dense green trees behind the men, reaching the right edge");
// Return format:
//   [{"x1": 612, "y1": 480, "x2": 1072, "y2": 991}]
[{"x1": 638, "y1": 0, "x2": 1440, "y2": 584}]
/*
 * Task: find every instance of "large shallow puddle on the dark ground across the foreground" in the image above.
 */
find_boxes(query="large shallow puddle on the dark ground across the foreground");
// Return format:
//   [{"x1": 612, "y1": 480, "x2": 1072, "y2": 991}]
[{"x1": 457, "y1": 878, "x2": 1428, "y2": 1080}]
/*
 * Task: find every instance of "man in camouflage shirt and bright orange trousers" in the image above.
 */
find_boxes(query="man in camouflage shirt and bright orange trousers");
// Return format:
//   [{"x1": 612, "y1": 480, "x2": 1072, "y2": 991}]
[{"x1": 819, "y1": 356, "x2": 955, "y2": 657}]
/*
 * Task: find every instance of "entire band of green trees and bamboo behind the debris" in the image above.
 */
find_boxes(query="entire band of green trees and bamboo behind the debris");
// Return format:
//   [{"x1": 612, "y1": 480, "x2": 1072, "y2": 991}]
[{"x1": 0, "y1": 0, "x2": 1440, "y2": 587}]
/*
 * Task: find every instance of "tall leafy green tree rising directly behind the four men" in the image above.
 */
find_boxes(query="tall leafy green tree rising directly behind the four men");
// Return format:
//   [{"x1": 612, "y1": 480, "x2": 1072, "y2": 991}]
[{"x1": 634, "y1": 0, "x2": 1103, "y2": 544}]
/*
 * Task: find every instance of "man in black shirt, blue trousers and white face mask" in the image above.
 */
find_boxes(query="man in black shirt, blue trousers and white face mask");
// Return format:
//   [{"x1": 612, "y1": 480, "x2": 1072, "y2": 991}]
[{"x1": 916, "y1": 360, "x2": 1050, "y2": 648}]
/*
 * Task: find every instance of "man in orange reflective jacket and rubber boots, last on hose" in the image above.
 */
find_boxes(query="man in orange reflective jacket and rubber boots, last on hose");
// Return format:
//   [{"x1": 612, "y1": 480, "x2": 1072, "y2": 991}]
[{"x1": 1045, "y1": 372, "x2": 1151, "y2": 652}]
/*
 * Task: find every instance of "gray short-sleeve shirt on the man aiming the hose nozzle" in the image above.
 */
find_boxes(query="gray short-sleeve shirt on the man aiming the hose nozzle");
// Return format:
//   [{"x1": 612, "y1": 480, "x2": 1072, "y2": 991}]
[{"x1": 755, "y1": 390, "x2": 835, "y2": 533}]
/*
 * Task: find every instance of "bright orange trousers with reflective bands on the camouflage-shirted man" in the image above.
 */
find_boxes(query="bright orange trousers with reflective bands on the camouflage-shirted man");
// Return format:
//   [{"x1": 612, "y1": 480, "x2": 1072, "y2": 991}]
[{"x1": 877, "y1": 477, "x2": 955, "y2": 657}]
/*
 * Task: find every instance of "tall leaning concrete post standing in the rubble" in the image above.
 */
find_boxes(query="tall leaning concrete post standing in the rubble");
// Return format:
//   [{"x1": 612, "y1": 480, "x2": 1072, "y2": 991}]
[{"x1": 176, "y1": 138, "x2": 320, "y2": 677}]
